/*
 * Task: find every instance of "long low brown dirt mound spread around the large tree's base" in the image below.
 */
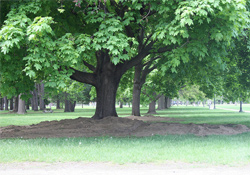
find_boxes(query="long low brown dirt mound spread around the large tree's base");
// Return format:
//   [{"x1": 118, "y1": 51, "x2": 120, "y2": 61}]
[{"x1": 0, "y1": 116, "x2": 250, "y2": 138}]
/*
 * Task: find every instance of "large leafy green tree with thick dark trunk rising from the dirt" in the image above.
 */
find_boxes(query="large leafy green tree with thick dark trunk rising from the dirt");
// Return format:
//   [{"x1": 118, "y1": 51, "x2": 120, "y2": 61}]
[{"x1": 0, "y1": 0, "x2": 247, "y2": 119}]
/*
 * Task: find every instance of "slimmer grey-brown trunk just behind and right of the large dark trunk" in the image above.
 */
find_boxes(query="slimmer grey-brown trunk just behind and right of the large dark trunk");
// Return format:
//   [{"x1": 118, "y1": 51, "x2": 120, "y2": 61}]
[{"x1": 132, "y1": 64, "x2": 143, "y2": 116}]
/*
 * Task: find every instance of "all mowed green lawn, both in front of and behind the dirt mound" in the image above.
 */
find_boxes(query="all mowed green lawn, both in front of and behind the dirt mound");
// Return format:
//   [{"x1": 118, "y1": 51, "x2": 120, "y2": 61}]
[{"x1": 0, "y1": 106, "x2": 250, "y2": 166}]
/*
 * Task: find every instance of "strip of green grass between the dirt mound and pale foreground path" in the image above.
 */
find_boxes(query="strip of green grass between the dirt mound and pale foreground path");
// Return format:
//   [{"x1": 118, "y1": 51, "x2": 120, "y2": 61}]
[{"x1": 0, "y1": 133, "x2": 250, "y2": 165}]
